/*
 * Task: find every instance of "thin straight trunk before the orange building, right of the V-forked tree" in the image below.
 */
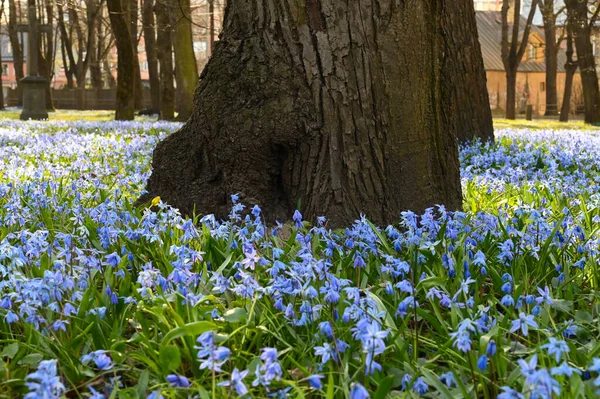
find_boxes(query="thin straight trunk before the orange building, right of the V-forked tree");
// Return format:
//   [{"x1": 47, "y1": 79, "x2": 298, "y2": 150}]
[{"x1": 542, "y1": 17, "x2": 558, "y2": 116}]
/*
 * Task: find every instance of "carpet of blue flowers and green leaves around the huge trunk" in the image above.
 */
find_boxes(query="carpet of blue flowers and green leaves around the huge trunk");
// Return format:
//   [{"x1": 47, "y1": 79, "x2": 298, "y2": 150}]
[{"x1": 0, "y1": 122, "x2": 600, "y2": 399}]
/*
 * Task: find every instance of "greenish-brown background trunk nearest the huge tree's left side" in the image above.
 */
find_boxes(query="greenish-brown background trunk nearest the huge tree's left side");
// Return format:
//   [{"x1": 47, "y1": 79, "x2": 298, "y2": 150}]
[{"x1": 172, "y1": 0, "x2": 198, "y2": 121}]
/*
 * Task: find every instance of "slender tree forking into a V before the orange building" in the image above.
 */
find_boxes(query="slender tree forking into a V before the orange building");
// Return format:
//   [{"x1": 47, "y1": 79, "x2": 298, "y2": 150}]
[{"x1": 501, "y1": 0, "x2": 537, "y2": 119}]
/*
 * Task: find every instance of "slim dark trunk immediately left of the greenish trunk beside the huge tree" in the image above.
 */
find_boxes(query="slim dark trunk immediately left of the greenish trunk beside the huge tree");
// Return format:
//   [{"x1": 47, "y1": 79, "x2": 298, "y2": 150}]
[{"x1": 154, "y1": 0, "x2": 175, "y2": 120}]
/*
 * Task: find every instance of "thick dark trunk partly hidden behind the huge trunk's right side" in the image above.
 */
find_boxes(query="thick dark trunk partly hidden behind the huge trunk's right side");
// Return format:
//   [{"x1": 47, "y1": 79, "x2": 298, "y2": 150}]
[{"x1": 441, "y1": 0, "x2": 494, "y2": 141}]
